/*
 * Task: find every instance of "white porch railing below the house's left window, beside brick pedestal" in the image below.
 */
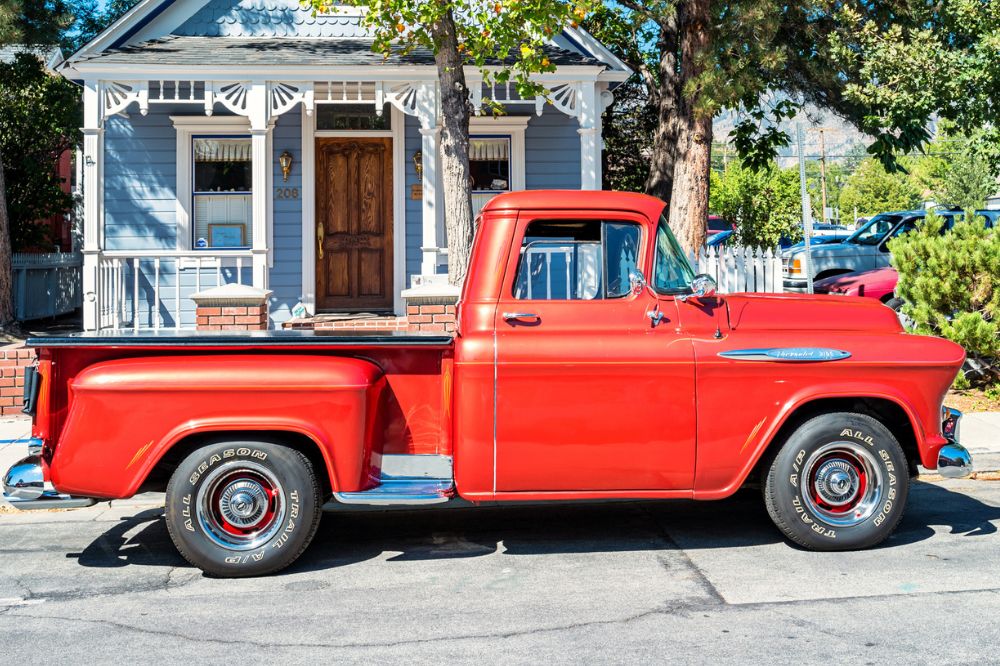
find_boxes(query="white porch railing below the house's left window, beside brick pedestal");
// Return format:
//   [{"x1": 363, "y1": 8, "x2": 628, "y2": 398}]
[{"x1": 96, "y1": 250, "x2": 253, "y2": 331}]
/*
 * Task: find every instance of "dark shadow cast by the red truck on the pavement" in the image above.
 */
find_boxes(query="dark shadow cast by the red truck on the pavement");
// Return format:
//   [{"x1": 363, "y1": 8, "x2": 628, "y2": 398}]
[{"x1": 67, "y1": 482, "x2": 1000, "y2": 572}]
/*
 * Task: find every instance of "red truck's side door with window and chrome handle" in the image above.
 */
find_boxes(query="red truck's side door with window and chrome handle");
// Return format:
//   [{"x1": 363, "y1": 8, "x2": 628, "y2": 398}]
[{"x1": 495, "y1": 211, "x2": 695, "y2": 493}]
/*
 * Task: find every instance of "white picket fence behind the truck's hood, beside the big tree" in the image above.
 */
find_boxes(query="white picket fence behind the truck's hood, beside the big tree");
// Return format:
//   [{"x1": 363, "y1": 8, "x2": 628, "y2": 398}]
[{"x1": 691, "y1": 247, "x2": 782, "y2": 293}]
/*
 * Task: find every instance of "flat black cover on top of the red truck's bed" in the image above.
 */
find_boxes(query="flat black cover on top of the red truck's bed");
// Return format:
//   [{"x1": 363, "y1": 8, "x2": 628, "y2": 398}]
[{"x1": 27, "y1": 330, "x2": 454, "y2": 348}]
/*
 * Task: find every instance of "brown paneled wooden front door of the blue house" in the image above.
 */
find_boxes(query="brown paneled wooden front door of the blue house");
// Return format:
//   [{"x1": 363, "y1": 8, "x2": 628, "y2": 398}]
[{"x1": 315, "y1": 138, "x2": 393, "y2": 311}]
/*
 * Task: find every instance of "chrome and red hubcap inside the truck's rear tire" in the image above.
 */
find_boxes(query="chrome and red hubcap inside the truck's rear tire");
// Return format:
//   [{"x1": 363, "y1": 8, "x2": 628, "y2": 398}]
[{"x1": 195, "y1": 460, "x2": 286, "y2": 551}]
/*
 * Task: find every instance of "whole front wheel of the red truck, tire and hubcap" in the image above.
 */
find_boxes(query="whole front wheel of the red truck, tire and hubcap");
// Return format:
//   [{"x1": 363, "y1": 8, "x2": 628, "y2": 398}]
[{"x1": 764, "y1": 412, "x2": 910, "y2": 550}]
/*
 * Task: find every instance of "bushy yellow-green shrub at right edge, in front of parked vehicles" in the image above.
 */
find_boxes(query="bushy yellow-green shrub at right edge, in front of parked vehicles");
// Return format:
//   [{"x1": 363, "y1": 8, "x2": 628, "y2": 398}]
[{"x1": 889, "y1": 214, "x2": 1000, "y2": 385}]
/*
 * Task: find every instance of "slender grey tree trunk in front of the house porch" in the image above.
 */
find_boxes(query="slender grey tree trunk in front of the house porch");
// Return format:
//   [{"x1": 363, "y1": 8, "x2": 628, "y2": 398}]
[{"x1": 431, "y1": 11, "x2": 473, "y2": 285}]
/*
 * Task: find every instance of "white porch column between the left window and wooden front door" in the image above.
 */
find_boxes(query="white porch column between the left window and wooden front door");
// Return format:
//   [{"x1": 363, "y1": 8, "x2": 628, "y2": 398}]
[{"x1": 247, "y1": 83, "x2": 272, "y2": 289}]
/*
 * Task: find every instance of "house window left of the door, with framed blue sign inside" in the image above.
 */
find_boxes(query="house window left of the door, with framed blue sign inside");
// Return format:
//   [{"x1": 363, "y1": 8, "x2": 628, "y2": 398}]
[{"x1": 192, "y1": 136, "x2": 253, "y2": 249}]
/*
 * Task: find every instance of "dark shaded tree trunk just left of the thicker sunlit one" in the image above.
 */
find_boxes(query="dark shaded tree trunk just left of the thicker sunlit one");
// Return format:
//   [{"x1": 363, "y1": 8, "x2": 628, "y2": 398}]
[{"x1": 646, "y1": 13, "x2": 681, "y2": 202}]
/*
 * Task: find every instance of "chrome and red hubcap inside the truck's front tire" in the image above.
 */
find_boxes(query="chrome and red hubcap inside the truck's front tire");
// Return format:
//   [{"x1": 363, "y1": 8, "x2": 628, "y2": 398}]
[{"x1": 799, "y1": 441, "x2": 885, "y2": 527}]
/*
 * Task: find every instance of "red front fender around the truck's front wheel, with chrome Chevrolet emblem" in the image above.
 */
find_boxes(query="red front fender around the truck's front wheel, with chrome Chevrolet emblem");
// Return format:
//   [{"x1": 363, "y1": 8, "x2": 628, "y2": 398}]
[{"x1": 695, "y1": 334, "x2": 962, "y2": 499}]
